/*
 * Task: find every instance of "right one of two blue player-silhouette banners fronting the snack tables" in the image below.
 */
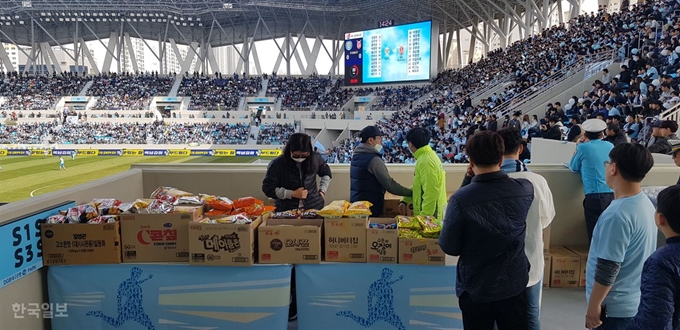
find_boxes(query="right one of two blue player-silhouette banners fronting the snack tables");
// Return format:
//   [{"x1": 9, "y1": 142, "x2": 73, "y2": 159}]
[{"x1": 295, "y1": 263, "x2": 463, "y2": 330}]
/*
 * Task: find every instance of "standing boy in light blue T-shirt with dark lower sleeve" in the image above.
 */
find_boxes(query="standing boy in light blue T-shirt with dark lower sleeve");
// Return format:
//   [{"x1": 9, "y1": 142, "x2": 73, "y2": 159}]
[{"x1": 586, "y1": 143, "x2": 657, "y2": 330}]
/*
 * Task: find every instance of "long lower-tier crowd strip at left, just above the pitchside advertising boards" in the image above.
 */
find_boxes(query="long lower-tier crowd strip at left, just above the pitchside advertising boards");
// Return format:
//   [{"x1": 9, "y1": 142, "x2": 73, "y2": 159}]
[{"x1": 0, "y1": 122, "x2": 250, "y2": 144}]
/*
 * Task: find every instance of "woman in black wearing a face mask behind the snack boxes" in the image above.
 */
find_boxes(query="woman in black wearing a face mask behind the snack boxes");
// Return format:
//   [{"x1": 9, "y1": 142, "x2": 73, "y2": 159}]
[{"x1": 262, "y1": 133, "x2": 331, "y2": 212}]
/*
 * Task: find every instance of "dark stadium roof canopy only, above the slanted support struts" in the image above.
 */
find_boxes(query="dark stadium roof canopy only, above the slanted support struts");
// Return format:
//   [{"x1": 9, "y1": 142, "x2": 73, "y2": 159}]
[{"x1": 0, "y1": 0, "x2": 580, "y2": 47}]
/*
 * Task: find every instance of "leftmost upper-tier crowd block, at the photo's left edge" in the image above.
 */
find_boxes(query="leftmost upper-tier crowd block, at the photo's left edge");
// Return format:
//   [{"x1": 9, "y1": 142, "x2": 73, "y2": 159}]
[{"x1": 0, "y1": 72, "x2": 89, "y2": 110}]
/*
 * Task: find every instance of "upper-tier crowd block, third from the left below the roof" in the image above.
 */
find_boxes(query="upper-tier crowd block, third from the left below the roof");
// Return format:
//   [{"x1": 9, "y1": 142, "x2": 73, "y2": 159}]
[{"x1": 177, "y1": 73, "x2": 262, "y2": 110}]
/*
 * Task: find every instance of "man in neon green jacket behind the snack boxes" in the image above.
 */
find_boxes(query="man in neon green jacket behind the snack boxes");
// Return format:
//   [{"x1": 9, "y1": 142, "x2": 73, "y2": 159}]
[{"x1": 399, "y1": 127, "x2": 446, "y2": 221}]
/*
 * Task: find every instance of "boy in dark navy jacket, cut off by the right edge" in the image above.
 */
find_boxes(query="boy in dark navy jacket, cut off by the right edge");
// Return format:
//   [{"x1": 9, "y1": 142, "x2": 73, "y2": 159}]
[{"x1": 628, "y1": 185, "x2": 680, "y2": 330}]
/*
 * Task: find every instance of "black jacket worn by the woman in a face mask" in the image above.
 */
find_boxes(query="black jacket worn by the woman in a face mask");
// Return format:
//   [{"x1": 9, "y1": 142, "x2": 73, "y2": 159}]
[{"x1": 262, "y1": 152, "x2": 331, "y2": 212}]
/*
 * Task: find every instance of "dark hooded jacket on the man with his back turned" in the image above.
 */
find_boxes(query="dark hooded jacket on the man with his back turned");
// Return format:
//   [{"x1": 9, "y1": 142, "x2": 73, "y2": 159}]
[{"x1": 439, "y1": 171, "x2": 534, "y2": 303}]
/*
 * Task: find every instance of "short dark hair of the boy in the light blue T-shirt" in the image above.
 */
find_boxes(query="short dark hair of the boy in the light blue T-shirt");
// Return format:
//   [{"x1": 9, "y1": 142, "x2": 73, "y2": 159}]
[{"x1": 609, "y1": 143, "x2": 654, "y2": 182}]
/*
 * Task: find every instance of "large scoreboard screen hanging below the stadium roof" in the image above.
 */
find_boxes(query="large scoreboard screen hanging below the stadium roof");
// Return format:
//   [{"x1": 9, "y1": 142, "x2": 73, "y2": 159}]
[{"x1": 345, "y1": 21, "x2": 432, "y2": 86}]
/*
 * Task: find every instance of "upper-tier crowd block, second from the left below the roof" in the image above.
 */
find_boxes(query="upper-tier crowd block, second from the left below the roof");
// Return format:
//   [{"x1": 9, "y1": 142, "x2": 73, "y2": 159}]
[{"x1": 87, "y1": 72, "x2": 175, "y2": 110}]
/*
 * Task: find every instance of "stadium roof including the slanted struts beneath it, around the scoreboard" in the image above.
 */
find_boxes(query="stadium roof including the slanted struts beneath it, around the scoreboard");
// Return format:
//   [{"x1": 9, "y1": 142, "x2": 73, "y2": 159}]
[{"x1": 0, "y1": 0, "x2": 584, "y2": 74}]
